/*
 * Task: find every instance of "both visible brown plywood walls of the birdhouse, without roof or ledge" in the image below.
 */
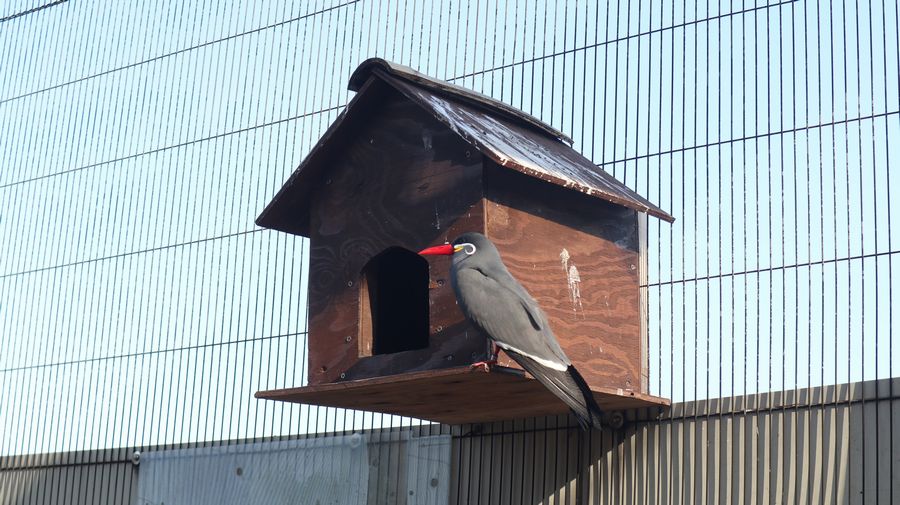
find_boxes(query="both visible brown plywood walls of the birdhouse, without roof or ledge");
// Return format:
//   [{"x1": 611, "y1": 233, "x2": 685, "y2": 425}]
[{"x1": 309, "y1": 85, "x2": 647, "y2": 402}]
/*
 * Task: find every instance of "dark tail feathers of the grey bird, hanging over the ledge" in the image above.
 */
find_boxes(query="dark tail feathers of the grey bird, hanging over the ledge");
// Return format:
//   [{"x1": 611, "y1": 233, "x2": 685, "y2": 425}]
[{"x1": 505, "y1": 349, "x2": 603, "y2": 430}]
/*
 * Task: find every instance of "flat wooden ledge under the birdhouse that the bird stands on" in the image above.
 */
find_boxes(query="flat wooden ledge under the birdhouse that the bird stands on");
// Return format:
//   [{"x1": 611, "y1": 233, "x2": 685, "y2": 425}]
[{"x1": 256, "y1": 367, "x2": 669, "y2": 424}]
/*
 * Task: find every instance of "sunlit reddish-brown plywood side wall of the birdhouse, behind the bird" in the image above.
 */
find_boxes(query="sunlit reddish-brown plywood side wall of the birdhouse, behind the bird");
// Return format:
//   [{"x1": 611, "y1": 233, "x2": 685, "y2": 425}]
[{"x1": 485, "y1": 166, "x2": 645, "y2": 392}]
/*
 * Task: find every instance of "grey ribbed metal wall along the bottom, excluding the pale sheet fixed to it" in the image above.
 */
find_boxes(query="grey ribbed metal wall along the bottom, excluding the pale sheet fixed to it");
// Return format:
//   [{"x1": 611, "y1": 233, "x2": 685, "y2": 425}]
[{"x1": 0, "y1": 380, "x2": 900, "y2": 505}]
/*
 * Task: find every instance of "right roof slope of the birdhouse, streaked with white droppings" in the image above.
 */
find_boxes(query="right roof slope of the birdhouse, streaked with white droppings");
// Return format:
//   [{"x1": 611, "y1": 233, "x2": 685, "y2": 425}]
[{"x1": 382, "y1": 75, "x2": 675, "y2": 223}]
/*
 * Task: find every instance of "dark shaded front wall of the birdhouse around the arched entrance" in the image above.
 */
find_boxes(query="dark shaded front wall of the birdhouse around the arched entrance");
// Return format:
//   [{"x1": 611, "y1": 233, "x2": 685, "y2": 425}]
[{"x1": 309, "y1": 94, "x2": 485, "y2": 385}]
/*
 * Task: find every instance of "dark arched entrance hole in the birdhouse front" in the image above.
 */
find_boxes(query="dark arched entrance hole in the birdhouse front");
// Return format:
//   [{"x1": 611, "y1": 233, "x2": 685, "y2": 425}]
[{"x1": 359, "y1": 247, "x2": 428, "y2": 357}]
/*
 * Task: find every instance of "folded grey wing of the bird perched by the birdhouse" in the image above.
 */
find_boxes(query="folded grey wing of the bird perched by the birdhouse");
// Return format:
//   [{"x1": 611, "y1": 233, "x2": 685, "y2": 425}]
[{"x1": 455, "y1": 268, "x2": 571, "y2": 370}]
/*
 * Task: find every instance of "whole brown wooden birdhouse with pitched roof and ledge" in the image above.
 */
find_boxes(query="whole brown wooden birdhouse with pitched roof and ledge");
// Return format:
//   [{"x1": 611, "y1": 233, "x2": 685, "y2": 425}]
[{"x1": 257, "y1": 59, "x2": 673, "y2": 423}]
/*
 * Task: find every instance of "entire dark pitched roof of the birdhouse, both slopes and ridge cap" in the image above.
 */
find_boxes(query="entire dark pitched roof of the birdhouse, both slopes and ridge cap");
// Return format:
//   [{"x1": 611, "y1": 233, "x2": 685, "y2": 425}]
[{"x1": 256, "y1": 58, "x2": 675, "y2": 236}]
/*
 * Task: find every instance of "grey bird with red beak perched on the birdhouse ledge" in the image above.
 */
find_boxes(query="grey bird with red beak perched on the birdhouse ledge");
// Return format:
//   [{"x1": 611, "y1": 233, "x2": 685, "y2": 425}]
[{"x1": 419, "y1": 233, "x2": 602, "y2": 429}]
